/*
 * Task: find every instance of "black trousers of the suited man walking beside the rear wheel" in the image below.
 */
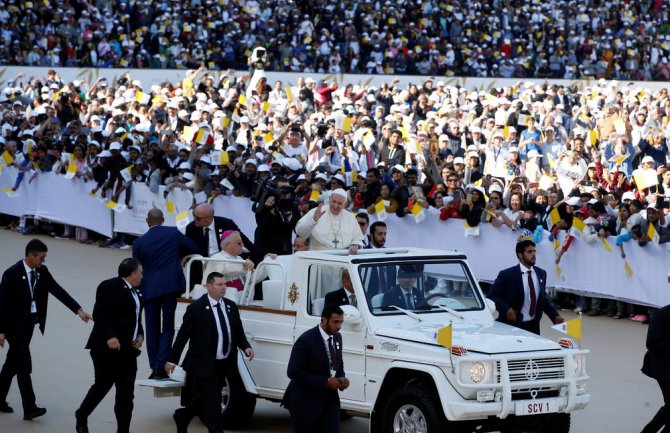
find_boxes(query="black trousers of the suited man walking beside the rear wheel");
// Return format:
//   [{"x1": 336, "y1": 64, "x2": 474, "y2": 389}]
[{"x1": 175, "y1": 359, "x2": 234, "y2": 433}]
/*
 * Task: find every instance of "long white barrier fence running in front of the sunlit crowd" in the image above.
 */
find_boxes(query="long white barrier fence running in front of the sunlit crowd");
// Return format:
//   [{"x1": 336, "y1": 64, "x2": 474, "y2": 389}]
[{"x1": 0, "y1": 168, "x2": 670, "y2": 306}]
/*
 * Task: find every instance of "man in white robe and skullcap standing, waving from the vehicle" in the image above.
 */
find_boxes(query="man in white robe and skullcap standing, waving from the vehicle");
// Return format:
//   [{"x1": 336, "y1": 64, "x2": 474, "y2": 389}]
[{"x1": 295, "y1": 188, "x2": 363, "y2": 254}]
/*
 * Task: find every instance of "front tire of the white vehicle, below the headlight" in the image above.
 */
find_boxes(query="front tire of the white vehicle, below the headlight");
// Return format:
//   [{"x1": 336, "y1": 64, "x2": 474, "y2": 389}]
[{"x1": 382, "y1": 385, "x2": 448, "y2": 433}]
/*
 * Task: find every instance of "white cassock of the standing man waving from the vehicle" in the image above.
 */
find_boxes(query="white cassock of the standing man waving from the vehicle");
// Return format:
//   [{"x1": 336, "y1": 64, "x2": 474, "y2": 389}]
[{"x1": 295, "y1": 207, "x2": 363, "y2": 250}]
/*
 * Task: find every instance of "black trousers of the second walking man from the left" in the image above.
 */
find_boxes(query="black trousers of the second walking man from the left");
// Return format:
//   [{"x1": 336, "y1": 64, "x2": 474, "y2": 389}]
[{"x1": 78, "y1": 350, "x2": 137, "y2": 433}]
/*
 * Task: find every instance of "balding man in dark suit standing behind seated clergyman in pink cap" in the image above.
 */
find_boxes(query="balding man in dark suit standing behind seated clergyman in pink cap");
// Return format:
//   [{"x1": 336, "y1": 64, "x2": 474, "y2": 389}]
[{"x1": 186, "y1": 203, "x2": 254, "y2": 288}]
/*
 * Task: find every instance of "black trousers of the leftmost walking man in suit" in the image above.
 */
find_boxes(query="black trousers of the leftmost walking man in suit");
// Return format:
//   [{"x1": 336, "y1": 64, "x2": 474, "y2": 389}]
[{"x1": 0, "y1": 322, "x2": 36, "y2": 413}]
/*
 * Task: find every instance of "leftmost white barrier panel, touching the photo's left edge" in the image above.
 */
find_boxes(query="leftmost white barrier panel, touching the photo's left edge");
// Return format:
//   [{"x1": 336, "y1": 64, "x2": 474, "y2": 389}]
[{"x1": 0, "y1": 167, "x2": 112, "y2": 236}]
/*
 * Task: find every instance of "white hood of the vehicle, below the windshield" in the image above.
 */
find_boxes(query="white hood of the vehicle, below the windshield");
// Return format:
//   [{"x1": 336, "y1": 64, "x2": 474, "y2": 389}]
[{"x1": 374, "y1": 321, "x2": 560, "y2": 354}]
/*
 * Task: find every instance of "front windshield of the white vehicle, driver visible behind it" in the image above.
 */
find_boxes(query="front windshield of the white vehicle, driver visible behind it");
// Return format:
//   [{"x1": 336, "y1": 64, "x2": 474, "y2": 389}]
[{"x1": 358, "y1": 261, "x2": 484, "y2": 315}]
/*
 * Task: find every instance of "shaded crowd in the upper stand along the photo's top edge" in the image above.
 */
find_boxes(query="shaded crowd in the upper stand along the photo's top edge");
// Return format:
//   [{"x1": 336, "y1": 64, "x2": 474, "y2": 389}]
[{"x1": 0, "y1": 0, "x2": 670, "y2": 80}]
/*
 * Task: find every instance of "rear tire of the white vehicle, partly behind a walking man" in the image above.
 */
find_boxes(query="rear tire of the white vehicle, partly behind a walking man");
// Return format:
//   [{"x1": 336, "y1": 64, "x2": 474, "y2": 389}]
[{"x1": 221, "y1": 371, "x2": 256, "y2": 430}]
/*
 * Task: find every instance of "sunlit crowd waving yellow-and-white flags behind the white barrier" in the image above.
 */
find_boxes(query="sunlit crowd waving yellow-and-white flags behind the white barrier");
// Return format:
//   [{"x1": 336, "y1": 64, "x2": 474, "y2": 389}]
[{"x1": 0, "y1": 69, "x2": 670, "y2": 321}]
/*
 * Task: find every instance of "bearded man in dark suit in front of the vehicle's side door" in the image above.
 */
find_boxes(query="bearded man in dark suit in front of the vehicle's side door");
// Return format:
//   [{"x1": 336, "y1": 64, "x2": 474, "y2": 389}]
[{"x1": 282, "y1": 304, "x2": 349, "y2": 433}]
